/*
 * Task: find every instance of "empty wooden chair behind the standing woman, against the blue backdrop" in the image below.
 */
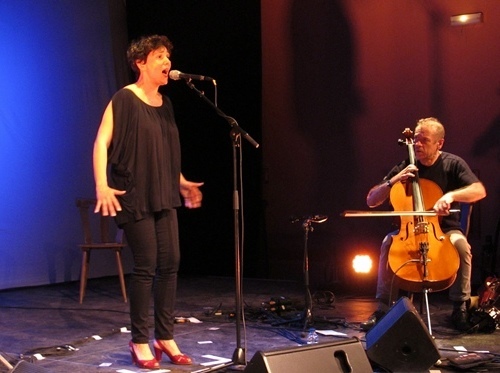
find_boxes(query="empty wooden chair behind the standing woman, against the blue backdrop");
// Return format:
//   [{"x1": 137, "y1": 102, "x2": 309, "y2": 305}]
[{"x1": 76, "y1": 198, "x2": 127, "y2": 304}]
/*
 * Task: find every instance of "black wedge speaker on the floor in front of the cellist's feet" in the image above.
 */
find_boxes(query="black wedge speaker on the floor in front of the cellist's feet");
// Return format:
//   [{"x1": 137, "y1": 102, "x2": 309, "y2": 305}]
[{"x1": 366, "y1": 297, "x2": 440, "y2": 372}]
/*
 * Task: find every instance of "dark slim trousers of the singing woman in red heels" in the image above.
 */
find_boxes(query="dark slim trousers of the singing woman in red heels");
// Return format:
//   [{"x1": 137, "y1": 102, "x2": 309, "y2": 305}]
[{"x1": 123, "y1": 210, "x2": 180, "y2": 343}]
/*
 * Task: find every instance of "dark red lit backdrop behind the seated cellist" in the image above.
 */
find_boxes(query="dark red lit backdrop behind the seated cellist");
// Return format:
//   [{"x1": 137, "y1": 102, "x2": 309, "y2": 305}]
[{"x1": 261, "y1": 0, "x2": 500, "y2": 294}]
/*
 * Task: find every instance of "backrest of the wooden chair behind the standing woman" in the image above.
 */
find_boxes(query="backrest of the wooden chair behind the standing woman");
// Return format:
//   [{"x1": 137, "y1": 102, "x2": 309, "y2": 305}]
[{"x1": 76, "y1": 198, "x2": 123, "y2": 244}]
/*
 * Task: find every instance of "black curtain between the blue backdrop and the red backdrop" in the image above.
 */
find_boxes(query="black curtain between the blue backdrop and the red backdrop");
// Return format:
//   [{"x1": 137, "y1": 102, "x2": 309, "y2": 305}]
[{"x1": 127, "y1": 0, "x2": 267, "y2": 276}]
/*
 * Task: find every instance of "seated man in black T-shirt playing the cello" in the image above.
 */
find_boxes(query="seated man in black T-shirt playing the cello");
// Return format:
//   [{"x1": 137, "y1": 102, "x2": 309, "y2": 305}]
[{"x1": 361, "y1": 118, "x2": 486, "y2": 331}]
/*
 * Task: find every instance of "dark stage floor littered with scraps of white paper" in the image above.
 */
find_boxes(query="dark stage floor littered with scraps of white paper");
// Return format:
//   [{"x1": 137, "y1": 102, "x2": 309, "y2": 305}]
[{"x1": 0, "y1": 277, "x2": 500, "y2": 373}]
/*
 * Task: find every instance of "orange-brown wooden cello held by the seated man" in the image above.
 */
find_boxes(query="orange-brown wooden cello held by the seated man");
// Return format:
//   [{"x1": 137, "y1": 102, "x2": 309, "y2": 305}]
[{"x1": 388, "y1": 128, "x2": 460, "y2": 292}]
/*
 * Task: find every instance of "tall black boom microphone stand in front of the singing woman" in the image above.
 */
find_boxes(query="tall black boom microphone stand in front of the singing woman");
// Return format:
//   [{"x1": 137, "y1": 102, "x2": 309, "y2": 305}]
[{"x1": 186, "y1": 79, "x2": 259, "y2": 373}]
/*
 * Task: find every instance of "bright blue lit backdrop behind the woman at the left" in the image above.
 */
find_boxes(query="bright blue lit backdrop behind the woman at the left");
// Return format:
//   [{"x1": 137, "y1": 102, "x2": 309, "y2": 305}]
[{"x1": 0, "y1": 0, "x2": 131, "y2": 289}]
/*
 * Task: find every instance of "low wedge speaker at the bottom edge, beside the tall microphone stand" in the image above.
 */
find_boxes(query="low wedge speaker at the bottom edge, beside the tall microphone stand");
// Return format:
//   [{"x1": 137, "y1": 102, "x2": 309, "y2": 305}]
[{"x1": 245, "y1": 338, "x2": 373, "y2": 373}]
